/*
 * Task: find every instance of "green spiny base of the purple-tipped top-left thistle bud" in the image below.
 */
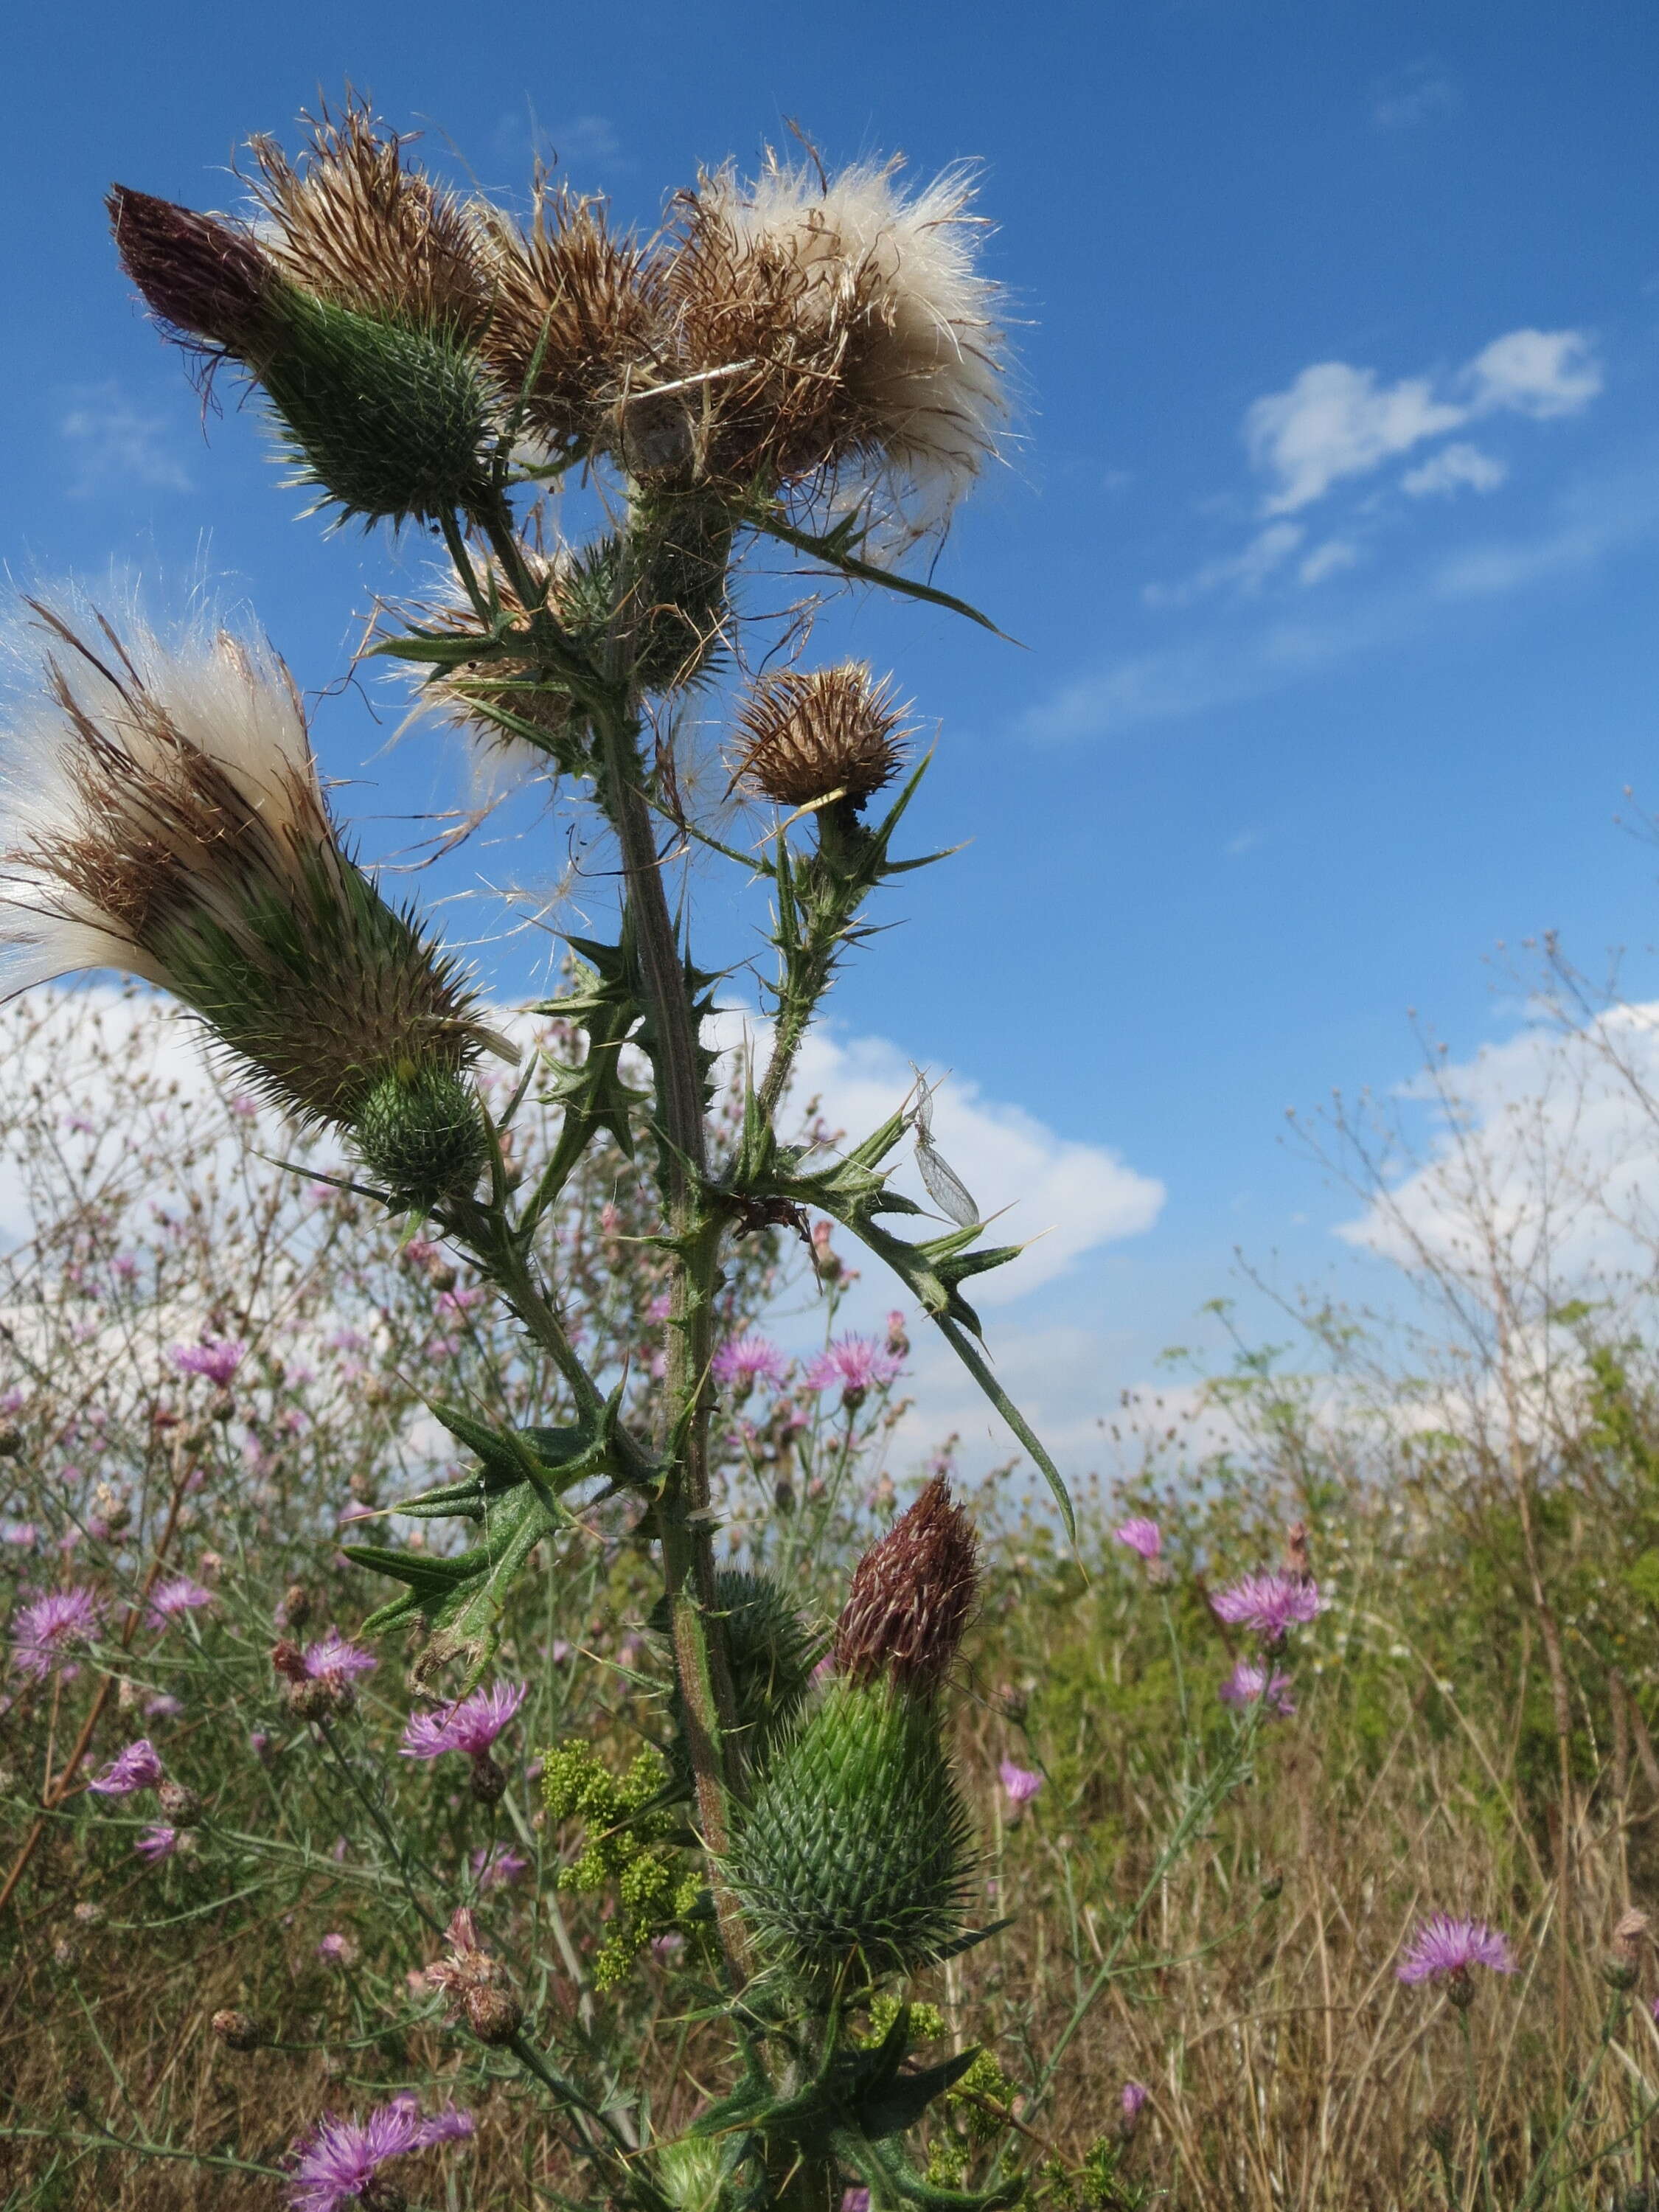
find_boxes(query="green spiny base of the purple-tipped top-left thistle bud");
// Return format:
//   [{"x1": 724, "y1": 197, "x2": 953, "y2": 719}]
[{"x1": 263, "y1": 285, "x2": 489, "y2": 522}]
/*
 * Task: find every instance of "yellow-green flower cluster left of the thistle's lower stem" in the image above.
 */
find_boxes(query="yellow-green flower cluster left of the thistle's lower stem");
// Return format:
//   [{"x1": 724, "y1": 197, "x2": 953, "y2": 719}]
[{"x1": 542, "y1": 1741, "x2": 703, "y2": 1989}]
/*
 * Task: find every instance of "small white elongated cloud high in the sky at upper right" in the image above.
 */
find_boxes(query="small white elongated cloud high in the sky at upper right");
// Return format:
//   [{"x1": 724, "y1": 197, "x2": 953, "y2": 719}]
[{"x1": 1243, "y1": 330, "x2": 1601, "y2": 515}]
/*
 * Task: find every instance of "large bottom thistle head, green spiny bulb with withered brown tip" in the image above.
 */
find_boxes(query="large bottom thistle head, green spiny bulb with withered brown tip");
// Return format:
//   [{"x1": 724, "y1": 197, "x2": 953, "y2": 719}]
[{"x1": 728, "y1": 1478, "x2": 978, "y2": 1978}]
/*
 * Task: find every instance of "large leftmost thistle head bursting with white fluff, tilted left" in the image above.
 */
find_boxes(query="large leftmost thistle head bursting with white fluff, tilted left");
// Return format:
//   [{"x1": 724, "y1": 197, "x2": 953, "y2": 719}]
[{"x1": 0, "y1": 599, "x2": 487, "y2": 1126}]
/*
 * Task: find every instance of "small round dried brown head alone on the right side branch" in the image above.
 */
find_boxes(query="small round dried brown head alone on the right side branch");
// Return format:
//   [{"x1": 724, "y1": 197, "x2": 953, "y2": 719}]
[{"x1": 732, "y1": 661, "x2": 909, "y2": 807}]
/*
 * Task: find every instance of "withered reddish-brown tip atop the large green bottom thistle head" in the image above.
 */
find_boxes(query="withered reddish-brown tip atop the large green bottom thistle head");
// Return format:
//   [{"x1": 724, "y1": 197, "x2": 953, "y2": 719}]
[{"x1": 834, "y1": 1475, "x2": 980, "y2": 1697}]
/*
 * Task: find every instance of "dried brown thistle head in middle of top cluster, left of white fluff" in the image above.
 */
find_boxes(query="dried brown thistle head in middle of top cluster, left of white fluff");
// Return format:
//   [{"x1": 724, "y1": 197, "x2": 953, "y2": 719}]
[{"x1": 471, "y1": 177, "x2": 664, "y2": 447}]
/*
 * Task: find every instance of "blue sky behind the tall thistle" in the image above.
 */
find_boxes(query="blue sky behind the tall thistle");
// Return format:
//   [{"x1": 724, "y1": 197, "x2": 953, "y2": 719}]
[{"x1": 0, "y1": 0, "x2": 1659, "y2": 1478}]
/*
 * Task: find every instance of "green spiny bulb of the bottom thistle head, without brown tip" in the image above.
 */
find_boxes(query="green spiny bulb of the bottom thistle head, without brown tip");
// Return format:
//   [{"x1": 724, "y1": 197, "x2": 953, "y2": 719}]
[{"x1": 728, "y1": 1679, "x2": 973, "y2": 1975}]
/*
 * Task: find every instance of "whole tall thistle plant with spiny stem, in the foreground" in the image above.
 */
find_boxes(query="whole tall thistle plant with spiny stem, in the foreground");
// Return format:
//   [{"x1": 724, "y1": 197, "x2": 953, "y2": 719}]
[{"x1": 0, "y1": 102, "x2": 1079, "y2": 2212}]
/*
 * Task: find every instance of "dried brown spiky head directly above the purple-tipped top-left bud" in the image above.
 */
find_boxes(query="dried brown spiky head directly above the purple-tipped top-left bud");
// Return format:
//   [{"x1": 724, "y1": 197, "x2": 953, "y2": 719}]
[{"x1": 248, "y1": 97, "x2": 491, "y2": 334}]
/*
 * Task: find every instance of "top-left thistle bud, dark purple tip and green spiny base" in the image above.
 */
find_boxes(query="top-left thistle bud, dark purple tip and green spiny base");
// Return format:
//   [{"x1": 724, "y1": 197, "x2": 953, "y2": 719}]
[{"x1": 108, "y1": 161, "x2": 491, "y2": 524}]
